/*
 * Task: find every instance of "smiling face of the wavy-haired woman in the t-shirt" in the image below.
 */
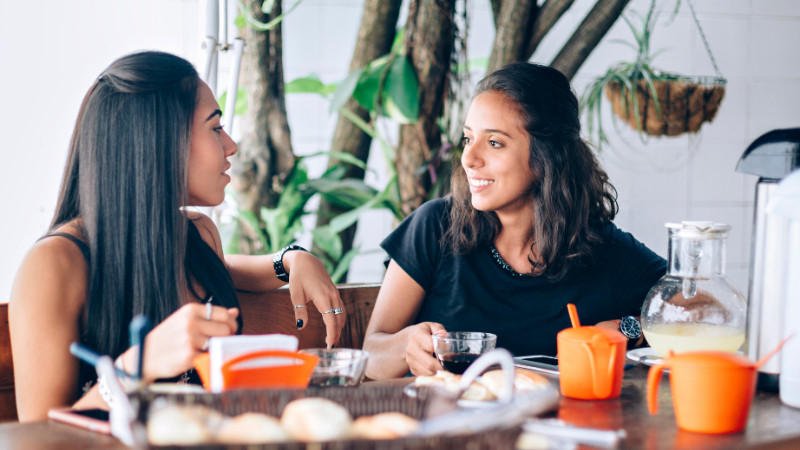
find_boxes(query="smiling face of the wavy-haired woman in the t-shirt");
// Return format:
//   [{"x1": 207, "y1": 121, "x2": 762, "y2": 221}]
[{"x1": 461, "y1": 91, "x2": 535, "y2": 215}]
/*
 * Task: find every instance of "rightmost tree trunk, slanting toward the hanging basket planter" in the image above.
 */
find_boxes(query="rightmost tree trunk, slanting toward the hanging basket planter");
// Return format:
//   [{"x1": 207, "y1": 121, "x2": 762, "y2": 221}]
[{"x1": 550, "y1": 0, "x2": 630, "y2": 79}]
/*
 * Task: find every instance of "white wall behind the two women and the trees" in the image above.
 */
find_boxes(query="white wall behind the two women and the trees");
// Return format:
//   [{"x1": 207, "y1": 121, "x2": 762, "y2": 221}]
[{"x1": 0, "y1": 0, "x2": 800, "y2": 301}]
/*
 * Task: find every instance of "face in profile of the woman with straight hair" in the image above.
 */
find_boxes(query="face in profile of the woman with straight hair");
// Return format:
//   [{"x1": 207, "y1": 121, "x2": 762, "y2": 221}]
[{"x1": 187, "y1": 81, "x2": 238, "y2": 206}]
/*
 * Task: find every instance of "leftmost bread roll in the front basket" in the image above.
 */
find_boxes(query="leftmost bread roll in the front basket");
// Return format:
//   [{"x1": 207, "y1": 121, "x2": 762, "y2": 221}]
[{"x1": 147, "y1": 405, "x2": 212, "y2": 445}]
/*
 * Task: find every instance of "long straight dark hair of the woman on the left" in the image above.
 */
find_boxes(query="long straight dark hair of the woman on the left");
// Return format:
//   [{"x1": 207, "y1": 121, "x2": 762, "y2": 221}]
[{"x1": 51, "y1": 52, "x2": 199, "y2": 355}]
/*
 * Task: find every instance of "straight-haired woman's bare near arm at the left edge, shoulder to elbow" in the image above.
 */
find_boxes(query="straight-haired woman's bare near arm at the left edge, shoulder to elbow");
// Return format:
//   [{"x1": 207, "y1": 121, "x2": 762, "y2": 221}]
[{"x1": 8, "y1": 237, "x2": 94, "y2": 422}]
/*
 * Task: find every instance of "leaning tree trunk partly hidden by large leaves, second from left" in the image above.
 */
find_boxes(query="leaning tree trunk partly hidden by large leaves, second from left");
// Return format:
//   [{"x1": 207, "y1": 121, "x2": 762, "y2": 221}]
[{"x1": 315, "y1": 0, "x2": 402, "y2": 279}]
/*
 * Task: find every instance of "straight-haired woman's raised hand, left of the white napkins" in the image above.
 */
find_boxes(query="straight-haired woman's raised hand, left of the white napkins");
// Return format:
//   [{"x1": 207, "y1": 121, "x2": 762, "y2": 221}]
[{"x1": 133, "y1": 302, "x2": 239, "y2": 383}]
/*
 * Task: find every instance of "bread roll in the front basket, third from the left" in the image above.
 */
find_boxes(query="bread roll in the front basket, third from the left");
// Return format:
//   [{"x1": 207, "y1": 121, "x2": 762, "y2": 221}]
[{"x1": 281, "y1": 397, "x2": 353, "y2": 442}]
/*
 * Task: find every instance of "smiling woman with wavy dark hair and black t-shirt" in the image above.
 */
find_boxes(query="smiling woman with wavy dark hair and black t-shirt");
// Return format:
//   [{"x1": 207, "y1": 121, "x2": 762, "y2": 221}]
[{"x1": 364, "y1": 63, "x2": 666, "y2": 379}]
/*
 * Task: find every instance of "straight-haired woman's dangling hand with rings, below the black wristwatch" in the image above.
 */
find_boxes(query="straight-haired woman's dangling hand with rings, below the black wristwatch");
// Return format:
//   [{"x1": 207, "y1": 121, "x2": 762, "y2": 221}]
[{"x1": 283, "y1": 250, "x2": 347, "y2": 348}]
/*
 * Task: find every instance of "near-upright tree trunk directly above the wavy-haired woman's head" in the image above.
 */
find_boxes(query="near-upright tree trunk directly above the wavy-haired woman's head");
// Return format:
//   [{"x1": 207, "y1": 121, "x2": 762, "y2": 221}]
[{"x1": 486, "y1": 0, "x2": 537, "y2": 73}]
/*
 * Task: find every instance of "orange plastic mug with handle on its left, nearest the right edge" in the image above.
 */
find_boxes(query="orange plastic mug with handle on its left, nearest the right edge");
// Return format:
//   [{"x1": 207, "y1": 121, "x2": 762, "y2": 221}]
[{"x1": 647, "y1": 351, "x2": 758, "y2": 433}]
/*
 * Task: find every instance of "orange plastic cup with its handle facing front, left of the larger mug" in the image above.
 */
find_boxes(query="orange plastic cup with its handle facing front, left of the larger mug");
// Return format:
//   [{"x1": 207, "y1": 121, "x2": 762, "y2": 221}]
[{"x1": 556, "y1": 326, "x2": 628, "y2": 400}]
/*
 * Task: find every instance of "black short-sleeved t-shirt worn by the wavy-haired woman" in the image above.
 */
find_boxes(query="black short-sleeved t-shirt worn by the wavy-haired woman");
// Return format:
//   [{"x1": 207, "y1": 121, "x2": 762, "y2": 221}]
[{"x1": 381, "y1": 199, "x2": 666, "y2": 356}]
